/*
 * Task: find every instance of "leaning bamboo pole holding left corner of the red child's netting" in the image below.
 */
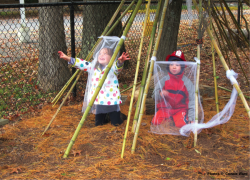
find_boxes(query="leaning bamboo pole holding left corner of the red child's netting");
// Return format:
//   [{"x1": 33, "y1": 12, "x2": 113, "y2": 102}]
[{"x1": 131, "y1": 0, "x2": 169, "y2": 154}]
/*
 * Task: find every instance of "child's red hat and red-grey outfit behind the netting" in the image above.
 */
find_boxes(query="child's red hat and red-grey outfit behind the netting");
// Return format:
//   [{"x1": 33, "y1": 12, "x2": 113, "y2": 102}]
[{"x1": 152, "y1": 50, "x2": 189, "y2": 127}]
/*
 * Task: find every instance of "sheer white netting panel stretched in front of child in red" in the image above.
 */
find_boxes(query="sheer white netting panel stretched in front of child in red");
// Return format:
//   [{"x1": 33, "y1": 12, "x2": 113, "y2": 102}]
[{"x1": 150, "y1": 61, "x2": 203, "y2": 135}]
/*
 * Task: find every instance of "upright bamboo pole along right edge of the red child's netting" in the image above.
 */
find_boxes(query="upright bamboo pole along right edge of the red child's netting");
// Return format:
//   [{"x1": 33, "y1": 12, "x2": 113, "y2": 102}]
[{"x1": 194, "y1": 0, "x2": 202, "y2": 147}]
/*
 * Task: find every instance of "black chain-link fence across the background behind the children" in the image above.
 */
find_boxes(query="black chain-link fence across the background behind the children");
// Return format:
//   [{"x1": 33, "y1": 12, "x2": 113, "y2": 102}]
[{"x1": 0, "y1": 2, "x2": 249, "y2": 119}]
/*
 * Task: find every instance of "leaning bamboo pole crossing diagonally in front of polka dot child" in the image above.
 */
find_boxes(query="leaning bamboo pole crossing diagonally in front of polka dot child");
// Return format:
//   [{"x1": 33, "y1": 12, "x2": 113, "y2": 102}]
[{"x1": 63, "y1": 0, "x2": 142, "y2": 158}]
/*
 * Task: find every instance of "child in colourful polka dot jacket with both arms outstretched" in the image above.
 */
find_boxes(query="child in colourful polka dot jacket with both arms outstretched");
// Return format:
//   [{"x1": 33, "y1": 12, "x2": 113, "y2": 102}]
[{"x1": 58, "y1": 36, "x2": 130, "y2": 126}]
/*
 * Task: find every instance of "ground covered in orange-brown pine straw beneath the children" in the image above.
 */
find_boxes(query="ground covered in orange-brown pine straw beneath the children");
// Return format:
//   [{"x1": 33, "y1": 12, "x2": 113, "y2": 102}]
[{"x1": 0, "y1": 90, "x2": 250, "y2": 179}]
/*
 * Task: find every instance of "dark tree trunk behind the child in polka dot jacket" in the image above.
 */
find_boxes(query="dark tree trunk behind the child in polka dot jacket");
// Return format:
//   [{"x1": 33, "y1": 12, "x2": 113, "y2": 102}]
[{"x1": 79, "y1": 1, "x2": 124, "y2": 59}]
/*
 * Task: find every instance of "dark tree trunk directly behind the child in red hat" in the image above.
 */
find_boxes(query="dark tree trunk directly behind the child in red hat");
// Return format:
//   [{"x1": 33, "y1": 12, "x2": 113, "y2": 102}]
[{"x1": 157, "y1": 0, "x2": 182, "y2": 61}]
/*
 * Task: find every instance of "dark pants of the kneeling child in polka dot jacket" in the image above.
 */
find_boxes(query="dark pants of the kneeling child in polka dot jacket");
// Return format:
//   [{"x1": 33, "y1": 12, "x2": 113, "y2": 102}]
[{"x1": 95, "y1": 111, "x2": 122, "y2": 126}]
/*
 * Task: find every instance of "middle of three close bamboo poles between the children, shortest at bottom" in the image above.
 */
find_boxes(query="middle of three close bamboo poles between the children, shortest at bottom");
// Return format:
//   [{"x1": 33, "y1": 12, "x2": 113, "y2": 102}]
[{"x1": 132, "y1": 0, "x2": 162, "y2": 133}]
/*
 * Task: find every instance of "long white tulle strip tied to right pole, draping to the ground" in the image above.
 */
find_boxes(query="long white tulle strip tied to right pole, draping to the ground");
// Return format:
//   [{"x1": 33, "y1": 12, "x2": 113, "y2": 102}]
[{"x1": 180, "y1": 70, "x2": 238, "y2": 136}]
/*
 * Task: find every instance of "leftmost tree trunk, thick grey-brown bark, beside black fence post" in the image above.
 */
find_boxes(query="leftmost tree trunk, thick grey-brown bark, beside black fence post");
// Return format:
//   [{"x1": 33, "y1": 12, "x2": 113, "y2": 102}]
[{"x1": 38, "y1": 0, "x2": 71, "y2": 91}]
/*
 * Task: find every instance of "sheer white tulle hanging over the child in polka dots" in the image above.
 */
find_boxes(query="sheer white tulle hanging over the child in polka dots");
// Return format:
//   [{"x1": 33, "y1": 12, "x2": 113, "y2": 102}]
[{"x1": 82, "y1": 36, "x2": 121, "y2": 114}]
